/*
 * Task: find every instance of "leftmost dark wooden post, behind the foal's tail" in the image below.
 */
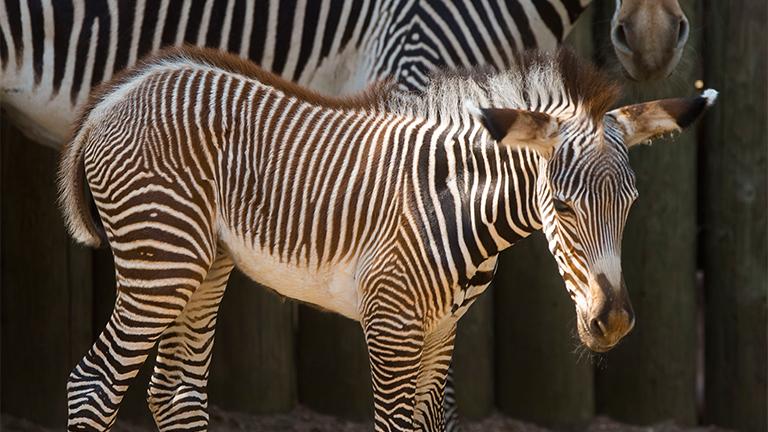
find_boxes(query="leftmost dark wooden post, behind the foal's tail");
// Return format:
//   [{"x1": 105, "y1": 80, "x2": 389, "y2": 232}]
[{"x1": 0, "y1": 123, "x2": 92, "y2": 428}]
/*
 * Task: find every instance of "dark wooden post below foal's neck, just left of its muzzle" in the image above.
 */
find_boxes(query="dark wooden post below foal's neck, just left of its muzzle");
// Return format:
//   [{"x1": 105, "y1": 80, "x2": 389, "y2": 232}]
[{"x1": 494, "y1": 8, "x2": 594, "y2": 426}]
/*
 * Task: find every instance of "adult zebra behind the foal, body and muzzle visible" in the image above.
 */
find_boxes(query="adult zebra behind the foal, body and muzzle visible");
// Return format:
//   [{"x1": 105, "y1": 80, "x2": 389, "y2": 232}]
[{"x1": 0, "y1": 0, "x2": 689, "y2": 147}]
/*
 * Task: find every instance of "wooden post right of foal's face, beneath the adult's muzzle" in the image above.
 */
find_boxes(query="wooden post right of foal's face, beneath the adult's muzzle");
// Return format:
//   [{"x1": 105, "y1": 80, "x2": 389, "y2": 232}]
[{"x1": 595, "y1": 0, "x2": 701, "y2": 424}]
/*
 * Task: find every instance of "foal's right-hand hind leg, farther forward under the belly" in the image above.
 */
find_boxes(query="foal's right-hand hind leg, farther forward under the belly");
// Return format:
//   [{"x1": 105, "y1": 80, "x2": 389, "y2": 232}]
[{"x1": 147, "y1": 246, "x2": 234, "y2": 431}]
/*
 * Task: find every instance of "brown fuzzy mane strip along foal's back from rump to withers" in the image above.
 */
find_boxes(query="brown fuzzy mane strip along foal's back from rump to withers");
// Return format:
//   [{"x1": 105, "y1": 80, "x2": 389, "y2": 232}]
[{"x1": 71, "y1": 46, "x2": 395, "y2": 143}]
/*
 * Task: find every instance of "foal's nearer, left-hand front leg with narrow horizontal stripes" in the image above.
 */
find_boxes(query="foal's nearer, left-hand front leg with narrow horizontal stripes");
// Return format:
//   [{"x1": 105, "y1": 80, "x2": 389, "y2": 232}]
[{"x1": 363, "y1": 311, "x2": 424, "y2": 432}]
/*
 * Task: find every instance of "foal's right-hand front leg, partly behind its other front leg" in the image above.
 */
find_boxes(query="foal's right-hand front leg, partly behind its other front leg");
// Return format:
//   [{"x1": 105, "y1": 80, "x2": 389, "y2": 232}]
[{"x1": 414, "y1": 323, "x2": 456, "y2": 432}]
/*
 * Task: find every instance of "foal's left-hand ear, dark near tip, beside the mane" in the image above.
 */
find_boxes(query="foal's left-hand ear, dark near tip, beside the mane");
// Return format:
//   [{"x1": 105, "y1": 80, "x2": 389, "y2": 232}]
[{"x1": 469, "y1": 106, "x2": 560, "y2": 158}]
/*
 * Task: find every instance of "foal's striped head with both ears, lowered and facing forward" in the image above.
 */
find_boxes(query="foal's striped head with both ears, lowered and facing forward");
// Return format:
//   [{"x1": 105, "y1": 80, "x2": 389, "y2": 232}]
[{"x1": 475, "y1": 79, "x2": 717, "y2": 352}]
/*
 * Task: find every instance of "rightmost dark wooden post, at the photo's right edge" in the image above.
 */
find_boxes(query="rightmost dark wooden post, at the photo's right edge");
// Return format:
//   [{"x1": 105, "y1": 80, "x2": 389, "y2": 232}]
[{"x1": 701, "y1": 0, "x2": 768, "y2": 432}]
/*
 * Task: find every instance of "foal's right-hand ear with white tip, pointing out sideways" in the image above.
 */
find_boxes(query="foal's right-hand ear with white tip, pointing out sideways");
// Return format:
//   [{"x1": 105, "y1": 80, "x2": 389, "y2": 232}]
[{"x1": 606, "y1": 89, "x2": 717, "y2": 147}]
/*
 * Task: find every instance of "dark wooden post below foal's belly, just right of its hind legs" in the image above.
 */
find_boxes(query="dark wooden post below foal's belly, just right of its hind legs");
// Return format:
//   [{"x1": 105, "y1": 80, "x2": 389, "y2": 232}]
[{"x1": 208, "y1": 271, "x2": 296, "y2": 414}]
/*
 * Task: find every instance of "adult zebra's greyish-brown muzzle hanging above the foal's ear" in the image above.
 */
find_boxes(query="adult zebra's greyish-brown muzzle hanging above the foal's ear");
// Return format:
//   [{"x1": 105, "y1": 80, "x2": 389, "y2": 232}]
[{"x1": 611, "y1": 0, "x2": 690, "y2": 81}]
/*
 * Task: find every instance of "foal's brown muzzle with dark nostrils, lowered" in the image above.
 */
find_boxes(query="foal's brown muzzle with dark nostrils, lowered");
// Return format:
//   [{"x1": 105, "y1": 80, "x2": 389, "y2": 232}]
[{"x1": 577, "y1": 273, "x2": 635, "y2": 352}]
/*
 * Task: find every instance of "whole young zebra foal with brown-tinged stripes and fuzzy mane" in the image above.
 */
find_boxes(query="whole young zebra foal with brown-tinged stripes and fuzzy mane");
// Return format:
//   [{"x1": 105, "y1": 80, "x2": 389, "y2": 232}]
[{"x1": 60, "y1": 45, "x2": 716, "y2": 431}]
